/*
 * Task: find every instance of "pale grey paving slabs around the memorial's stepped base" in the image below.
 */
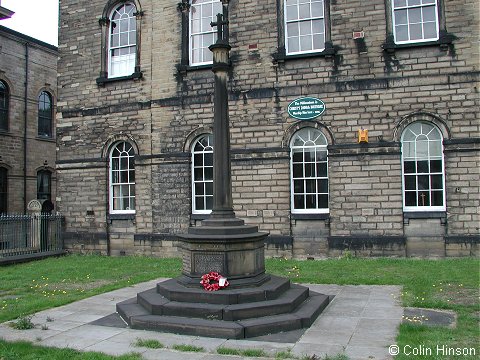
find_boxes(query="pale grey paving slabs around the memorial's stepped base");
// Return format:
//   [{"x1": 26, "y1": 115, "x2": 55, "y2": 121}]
[{"x1": 0, "y1": 279, "x2": 403, "y2": 360}]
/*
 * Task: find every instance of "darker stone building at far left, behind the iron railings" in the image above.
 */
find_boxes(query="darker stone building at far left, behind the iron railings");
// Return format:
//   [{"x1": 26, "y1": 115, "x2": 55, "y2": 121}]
[{"x1": 0, "y1": 26, "x2": 58, "y2": 214}]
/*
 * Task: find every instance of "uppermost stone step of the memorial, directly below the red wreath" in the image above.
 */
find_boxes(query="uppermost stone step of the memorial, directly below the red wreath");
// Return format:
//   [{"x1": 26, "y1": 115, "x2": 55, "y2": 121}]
[{"x1": 157, "y1": 275, "x2": 290, "y2": 305}]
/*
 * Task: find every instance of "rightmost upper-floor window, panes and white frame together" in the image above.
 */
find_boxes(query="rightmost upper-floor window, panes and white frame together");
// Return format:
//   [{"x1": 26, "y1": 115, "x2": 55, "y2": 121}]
[{"x1": 391, "y1": 0, "x2": 439, "y2": 44}]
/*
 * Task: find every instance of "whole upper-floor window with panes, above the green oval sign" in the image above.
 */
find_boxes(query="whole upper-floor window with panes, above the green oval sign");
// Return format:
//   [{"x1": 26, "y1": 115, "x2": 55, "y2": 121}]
[{"x1": 284, "y1": 0, "x2": 325, "y2": 55}]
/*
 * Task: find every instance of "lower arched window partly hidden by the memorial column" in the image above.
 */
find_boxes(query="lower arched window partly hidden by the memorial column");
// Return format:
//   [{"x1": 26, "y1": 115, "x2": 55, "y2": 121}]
[{"x1": 192, "y1": 134, "x2": 213, "y2": 214}]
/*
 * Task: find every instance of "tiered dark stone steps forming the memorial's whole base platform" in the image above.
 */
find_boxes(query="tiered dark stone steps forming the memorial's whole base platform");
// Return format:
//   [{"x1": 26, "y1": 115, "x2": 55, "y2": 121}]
[{"x1": 117, "y1": 274, "x2": 329, "y2": 339}]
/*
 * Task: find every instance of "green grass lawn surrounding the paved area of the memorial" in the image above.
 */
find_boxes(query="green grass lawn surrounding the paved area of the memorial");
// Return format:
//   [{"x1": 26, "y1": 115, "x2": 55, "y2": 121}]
[{"x1": 0, "y1": 255, "x2": 480, "y2": 360}]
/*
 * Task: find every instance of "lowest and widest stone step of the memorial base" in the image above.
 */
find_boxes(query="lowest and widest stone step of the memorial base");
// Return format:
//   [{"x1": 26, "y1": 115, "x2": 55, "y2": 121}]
[{"x1": 117, "y1": 292, "x2": 329, "y2": 339}]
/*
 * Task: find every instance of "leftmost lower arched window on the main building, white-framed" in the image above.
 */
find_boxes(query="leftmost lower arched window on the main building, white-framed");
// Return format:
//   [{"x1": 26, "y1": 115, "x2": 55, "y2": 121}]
[{"x1": 109, "y1": 141, "x2": 135, "y2": 214}]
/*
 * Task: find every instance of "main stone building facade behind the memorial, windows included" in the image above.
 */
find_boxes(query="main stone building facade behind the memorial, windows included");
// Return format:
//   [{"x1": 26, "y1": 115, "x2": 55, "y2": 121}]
[{"x1": 56, "y1": 0, "x2": 480, "y2": 257}]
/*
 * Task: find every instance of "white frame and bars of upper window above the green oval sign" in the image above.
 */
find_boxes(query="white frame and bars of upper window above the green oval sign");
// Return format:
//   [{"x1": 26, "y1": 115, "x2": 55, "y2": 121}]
[{"x1": 283, "y1": 0, "x2": 327, "y2": 55}]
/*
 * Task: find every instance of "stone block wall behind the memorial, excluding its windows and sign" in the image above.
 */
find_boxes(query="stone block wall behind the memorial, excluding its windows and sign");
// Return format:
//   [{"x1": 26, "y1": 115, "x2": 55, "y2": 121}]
[{"x1": 57, "y1": 0, "x2": 480, "y2": 257}]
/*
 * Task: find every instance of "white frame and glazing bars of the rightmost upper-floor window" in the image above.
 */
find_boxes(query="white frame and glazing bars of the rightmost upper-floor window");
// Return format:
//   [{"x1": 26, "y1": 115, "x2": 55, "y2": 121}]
[{"x1": 389, "y1": 0, "x2": 440, "y2": 45}]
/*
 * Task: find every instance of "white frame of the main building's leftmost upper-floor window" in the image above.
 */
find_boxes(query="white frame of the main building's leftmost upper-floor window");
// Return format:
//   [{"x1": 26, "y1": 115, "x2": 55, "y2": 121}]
[{"x1": 108, "y1": 2, "x2": 138, "y2": 78}]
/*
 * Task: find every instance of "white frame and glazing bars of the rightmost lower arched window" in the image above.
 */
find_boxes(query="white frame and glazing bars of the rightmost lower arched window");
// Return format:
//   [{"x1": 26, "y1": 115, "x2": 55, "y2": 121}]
[{"x1": 401, "y1": 121, "x2": 446, "y2": 212}]
